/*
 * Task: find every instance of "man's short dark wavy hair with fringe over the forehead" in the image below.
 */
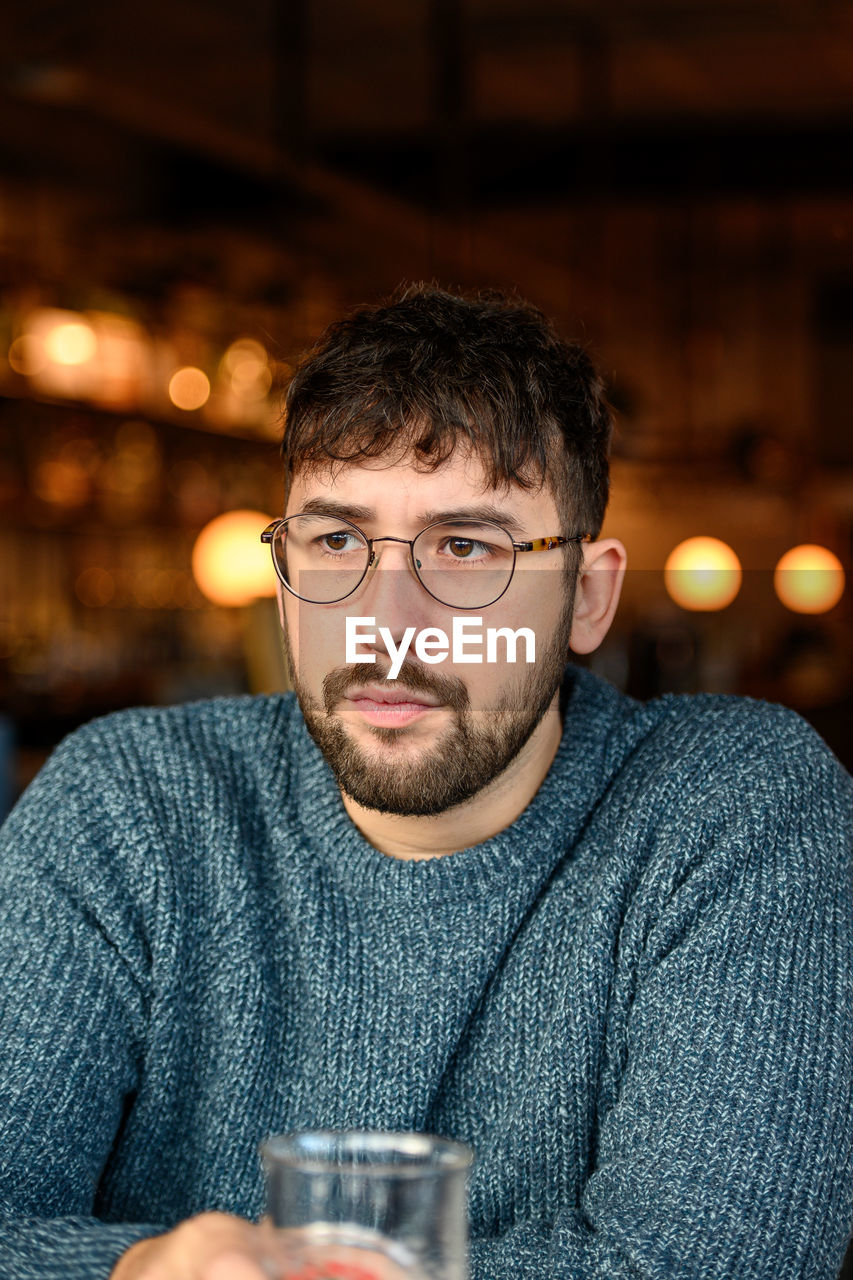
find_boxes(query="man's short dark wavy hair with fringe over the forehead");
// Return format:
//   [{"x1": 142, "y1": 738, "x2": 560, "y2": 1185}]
[{"x1": 282, "y1": 284, "x2": 612, "y2": 560}]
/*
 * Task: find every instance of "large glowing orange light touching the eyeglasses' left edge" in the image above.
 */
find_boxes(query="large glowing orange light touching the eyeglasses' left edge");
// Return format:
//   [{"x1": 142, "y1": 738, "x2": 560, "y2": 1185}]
[{"x1": 192, "y1": 511, "x2": 275, "y2": 605}]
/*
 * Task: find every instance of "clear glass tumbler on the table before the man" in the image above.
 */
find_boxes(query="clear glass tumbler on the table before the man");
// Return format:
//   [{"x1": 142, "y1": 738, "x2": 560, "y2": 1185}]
[{"x1": 261, "y1": 1129, "x2": 474, "y2": 1280}]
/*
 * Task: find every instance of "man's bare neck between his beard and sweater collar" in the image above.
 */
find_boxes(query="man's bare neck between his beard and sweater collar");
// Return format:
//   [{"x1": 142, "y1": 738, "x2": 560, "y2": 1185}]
[{"x1": 343, "y1": 699, "x2": 562, "y2": 860}]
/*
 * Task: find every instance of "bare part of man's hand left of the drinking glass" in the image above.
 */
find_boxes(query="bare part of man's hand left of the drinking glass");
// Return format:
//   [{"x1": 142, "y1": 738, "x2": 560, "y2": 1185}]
[{"x1": 110, "y1": 1213, "x2": 284, "y2": 1280}]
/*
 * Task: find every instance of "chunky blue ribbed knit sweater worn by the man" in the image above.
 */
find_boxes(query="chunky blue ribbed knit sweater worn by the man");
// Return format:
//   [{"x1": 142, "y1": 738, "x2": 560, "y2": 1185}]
[{"x1": 0, "y1": 667, "x2": 853, "y2": 1280}]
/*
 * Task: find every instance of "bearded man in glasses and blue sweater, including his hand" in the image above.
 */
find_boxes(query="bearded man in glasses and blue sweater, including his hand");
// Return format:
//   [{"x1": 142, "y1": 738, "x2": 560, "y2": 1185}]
[{"x1": 0, "y1": 288, "x2": 853, "y2": 1280}]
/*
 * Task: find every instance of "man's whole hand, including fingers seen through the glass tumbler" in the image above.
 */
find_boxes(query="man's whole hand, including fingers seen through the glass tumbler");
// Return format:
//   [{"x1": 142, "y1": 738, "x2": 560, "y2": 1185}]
[{"x1": 110, "y1": 1213, "x2": 418, "y2": 1280}]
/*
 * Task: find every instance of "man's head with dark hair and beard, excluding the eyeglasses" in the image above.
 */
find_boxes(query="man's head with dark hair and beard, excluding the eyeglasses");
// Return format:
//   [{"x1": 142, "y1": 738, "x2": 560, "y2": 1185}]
[{"x1": 280, "y1": 287, "x2": 621, "y2": 815}]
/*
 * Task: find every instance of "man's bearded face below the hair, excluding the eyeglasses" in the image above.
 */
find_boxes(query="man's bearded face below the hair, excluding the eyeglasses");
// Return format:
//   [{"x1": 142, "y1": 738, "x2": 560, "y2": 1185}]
[{"x1": 279, "y1": 449, "x2": 574, "y2": 815}]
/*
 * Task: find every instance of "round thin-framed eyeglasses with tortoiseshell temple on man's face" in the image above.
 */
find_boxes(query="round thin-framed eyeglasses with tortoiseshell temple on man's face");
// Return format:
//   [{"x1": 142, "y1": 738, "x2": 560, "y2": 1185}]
[{"x1": 261, "y1": 512, "x2": 590, "y2": 609}]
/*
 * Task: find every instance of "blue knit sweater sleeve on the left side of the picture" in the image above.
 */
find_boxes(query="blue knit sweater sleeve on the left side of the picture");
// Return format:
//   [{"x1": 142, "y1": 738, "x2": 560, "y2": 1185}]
[{"x1": 0, "y1": 732, "x2": 165, "y2": 1280}]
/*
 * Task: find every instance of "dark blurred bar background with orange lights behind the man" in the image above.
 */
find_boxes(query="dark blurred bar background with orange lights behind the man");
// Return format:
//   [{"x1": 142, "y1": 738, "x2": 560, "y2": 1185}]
[{"x1": 0, "y1": 0, "x2": 853, "y2": 814}]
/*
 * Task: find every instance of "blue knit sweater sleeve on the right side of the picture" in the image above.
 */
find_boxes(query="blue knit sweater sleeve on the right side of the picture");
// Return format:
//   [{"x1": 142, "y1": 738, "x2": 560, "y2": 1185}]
[{"x1": 471, "y1": 708, "x2": 853, "y2": 1280}]
